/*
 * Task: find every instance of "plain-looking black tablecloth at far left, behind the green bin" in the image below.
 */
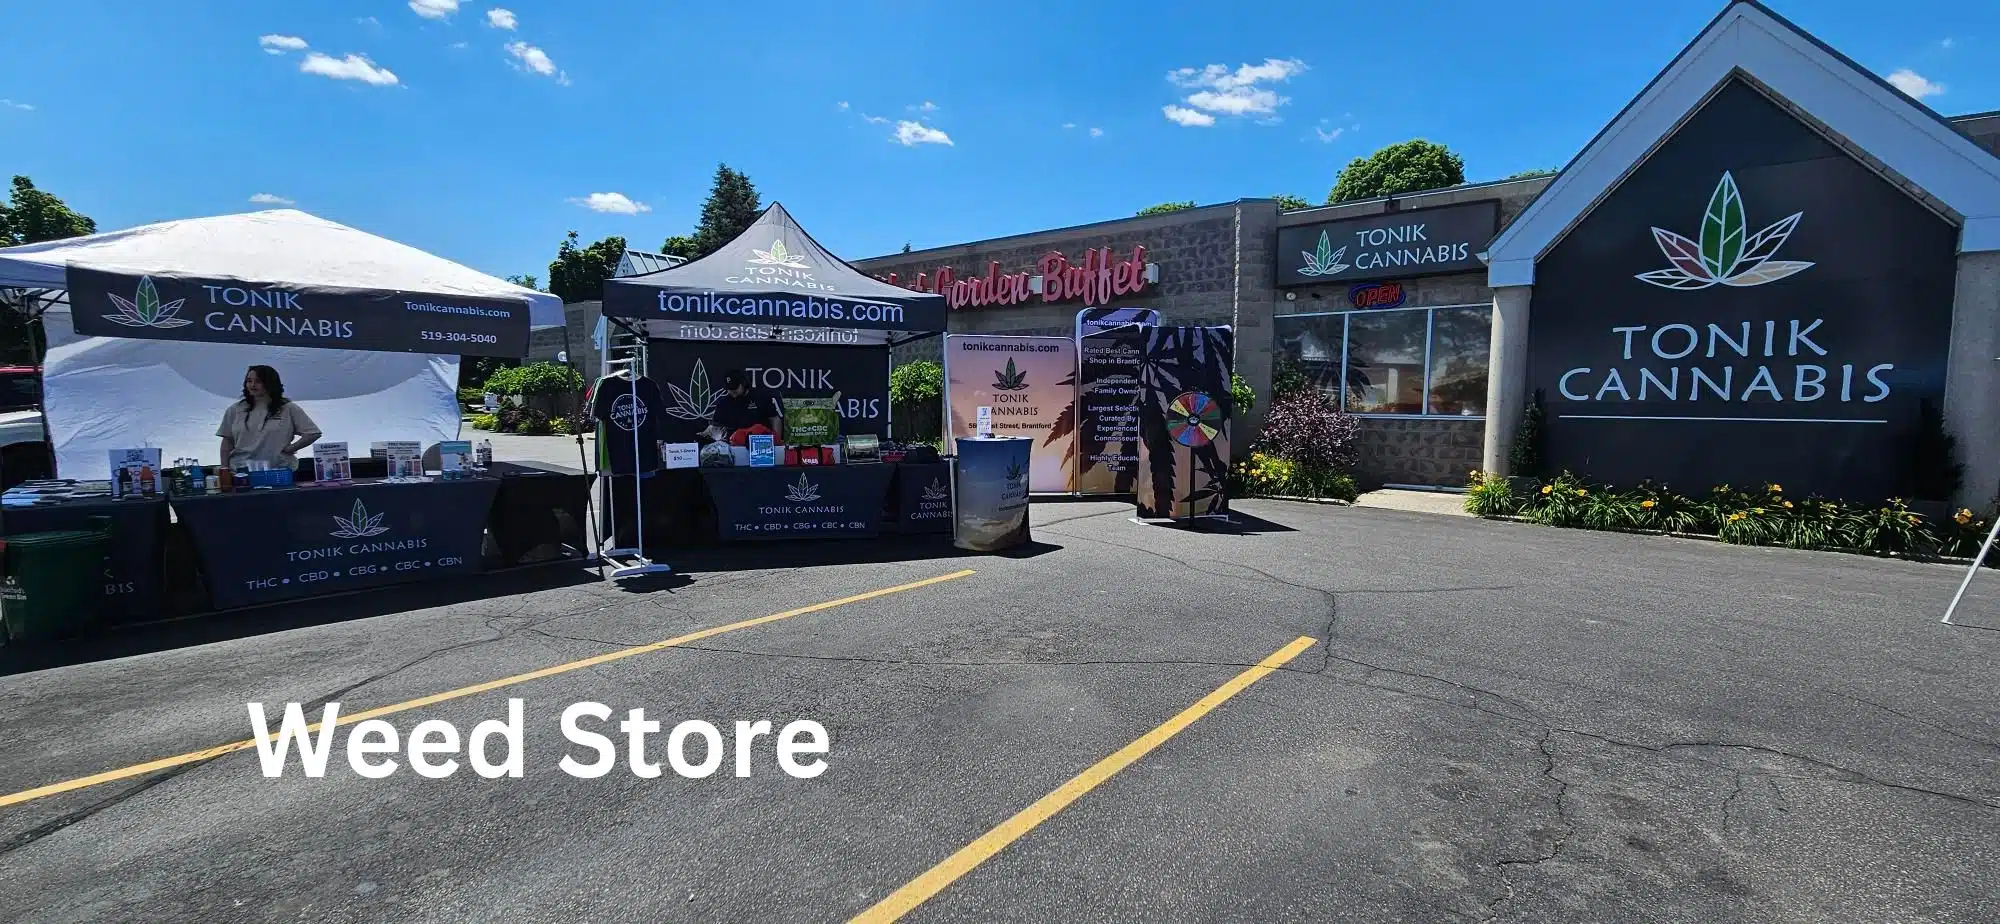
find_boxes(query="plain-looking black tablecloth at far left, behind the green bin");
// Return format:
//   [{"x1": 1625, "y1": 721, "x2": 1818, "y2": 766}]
[{"x1": 0, "y1": 498, "x2": 166, "y2": 622}]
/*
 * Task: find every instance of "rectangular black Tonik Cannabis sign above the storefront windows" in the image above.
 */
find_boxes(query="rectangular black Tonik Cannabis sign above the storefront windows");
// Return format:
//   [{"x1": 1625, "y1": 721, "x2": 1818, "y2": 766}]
[{"x1": 1278, "y1": 200, "x2": 1500, "y2": 286}]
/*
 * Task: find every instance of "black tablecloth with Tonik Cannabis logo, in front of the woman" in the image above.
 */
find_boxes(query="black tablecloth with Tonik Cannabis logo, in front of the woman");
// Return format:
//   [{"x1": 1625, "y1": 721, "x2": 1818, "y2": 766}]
[{"x1": 172, "y1": 478, "x2": 500, "y2": 610}]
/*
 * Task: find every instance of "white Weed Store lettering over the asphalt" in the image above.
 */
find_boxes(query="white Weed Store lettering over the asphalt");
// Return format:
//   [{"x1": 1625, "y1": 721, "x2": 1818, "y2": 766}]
[{"x1": 248, "y1": 698, "x2": 830, "y2": 780}]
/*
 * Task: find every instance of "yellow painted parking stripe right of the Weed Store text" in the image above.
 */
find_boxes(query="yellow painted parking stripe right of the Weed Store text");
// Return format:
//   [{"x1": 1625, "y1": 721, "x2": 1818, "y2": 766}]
[{"x1": 850, "y1": 636, "x2": 1318, "y2": 924}]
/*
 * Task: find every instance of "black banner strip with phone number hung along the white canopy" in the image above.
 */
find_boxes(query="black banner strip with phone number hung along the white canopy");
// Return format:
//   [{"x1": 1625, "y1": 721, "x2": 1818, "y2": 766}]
[{"x1": 66, "y1": 266, "x2": 528, "y2": 358}]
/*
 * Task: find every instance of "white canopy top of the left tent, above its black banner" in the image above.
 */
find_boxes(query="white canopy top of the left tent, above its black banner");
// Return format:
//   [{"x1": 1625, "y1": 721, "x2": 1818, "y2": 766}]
[{"x1": 0, "y1": 208, "x2": 562, "y2": 328}]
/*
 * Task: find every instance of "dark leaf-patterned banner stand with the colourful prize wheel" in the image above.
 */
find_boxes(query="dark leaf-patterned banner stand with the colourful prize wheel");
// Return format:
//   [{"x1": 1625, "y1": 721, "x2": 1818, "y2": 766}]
[{"x1": 1134, "y1": 328, "x2": 1236, "y2": 520}]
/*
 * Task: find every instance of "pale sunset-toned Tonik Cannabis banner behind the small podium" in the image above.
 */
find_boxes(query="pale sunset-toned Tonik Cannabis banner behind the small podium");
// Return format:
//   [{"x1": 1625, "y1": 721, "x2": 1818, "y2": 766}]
[{"x1": 944, "y1": 334, "x2": 1076, "y2": 494}]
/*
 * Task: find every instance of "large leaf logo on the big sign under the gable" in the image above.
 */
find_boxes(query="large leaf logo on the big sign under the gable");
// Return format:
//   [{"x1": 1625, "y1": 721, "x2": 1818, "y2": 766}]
[{"x1": 1636, "y1": 172, "x2": 1812, "y2": 292}]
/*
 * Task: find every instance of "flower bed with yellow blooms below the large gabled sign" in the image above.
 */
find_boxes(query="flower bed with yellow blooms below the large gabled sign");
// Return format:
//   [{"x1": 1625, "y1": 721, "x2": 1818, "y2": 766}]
[{"x1": 1466, "y1": 472, "x2": 1992, "y2": 564}]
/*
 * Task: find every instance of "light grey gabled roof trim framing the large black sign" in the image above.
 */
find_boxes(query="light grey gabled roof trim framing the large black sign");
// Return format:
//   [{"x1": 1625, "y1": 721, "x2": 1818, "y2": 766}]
[{"x1": 1486, "y1": 0, "x2": 2000, "y2": 286}]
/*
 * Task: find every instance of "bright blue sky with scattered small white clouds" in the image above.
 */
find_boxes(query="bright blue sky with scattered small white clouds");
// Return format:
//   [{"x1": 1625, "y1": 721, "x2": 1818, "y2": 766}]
[{"x1": 0, "y1": 0, "x2": 2000, "y2": 276}]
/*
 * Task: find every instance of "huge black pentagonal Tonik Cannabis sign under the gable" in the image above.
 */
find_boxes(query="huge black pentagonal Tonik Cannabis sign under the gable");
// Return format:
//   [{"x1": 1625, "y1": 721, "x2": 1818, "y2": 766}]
[{"x1": 1528, "y1": 84, "x2": 1956, "y2": 500}]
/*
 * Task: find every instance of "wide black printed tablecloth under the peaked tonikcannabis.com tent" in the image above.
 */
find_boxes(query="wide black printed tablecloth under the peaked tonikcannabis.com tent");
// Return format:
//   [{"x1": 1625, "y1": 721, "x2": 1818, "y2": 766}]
[{"x1": 700, "y1": 464, "x2": 896, "y2": 542}]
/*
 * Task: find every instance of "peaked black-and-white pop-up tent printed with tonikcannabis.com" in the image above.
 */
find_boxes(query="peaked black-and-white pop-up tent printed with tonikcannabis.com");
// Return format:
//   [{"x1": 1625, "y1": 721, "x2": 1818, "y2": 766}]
[{"x1": 604, "y1": 204, "x2": 946, "y2": 440}]
